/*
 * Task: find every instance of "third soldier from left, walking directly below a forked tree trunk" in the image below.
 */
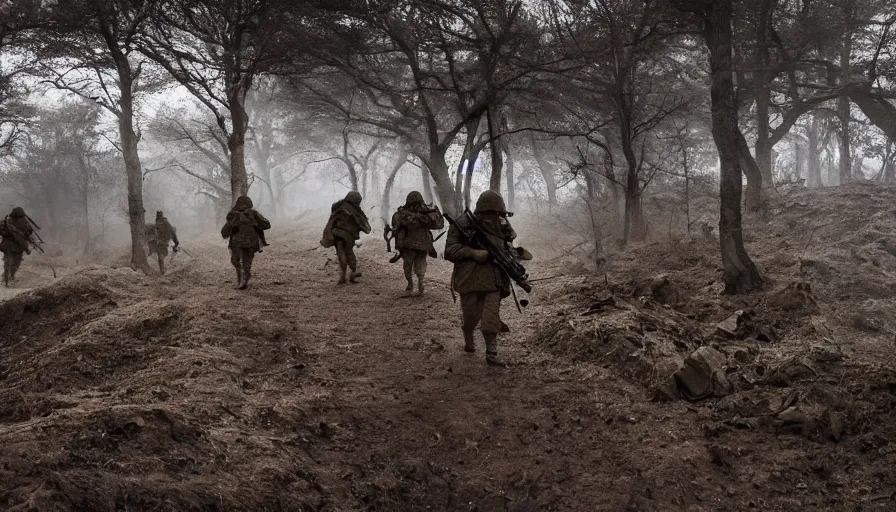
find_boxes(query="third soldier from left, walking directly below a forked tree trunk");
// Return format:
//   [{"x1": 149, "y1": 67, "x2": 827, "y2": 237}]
[{"x1": 221, "y1": 196, "x2": 271, "y2": 290}]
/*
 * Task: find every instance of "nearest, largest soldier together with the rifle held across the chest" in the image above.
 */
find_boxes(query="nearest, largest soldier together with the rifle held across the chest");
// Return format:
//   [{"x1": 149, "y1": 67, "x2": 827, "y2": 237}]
[{"x1": 445, "y1": 191, "x2": 532, "y2": 367}]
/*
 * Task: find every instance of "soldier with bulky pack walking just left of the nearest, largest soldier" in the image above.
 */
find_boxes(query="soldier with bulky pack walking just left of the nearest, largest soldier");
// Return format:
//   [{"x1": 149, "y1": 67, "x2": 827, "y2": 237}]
[{"x1": 392, "y1": 190, "x2": 445, "y2": 295}]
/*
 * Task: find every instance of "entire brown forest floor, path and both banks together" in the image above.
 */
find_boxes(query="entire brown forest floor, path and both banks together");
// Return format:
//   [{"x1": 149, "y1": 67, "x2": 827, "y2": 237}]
[{"x1": 0, "y1": 186, "x2": 896, "y2": 511}]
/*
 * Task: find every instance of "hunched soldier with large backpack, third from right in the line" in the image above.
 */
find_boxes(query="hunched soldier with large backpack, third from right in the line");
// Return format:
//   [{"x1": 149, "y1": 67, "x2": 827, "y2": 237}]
[{"x1": 321, "y1": 190, "x2": 370, "y2": 284}]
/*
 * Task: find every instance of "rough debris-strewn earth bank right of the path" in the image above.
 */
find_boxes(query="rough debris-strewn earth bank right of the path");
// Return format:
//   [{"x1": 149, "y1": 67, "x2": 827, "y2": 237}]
[{"x1": 520, "y1": 185, "x2": 896, "y2": 508}]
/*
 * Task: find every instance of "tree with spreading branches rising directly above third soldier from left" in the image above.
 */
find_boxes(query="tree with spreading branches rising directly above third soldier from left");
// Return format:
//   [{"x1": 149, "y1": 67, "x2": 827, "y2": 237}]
[{"x1": 138, "y1": 0, "x2": 298, "y2": 202}]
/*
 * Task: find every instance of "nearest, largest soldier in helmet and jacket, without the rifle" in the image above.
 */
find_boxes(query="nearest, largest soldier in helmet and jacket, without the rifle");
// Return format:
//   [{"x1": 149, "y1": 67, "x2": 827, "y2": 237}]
[{"x1": 445, "y1": 191, "x2": 532, "y2": 367}]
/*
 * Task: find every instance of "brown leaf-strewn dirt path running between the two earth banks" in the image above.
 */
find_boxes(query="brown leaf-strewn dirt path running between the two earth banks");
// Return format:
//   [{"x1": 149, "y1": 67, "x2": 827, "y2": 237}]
[{"x1": 130, "y1": 234, "x2": 736, "y2": 510}]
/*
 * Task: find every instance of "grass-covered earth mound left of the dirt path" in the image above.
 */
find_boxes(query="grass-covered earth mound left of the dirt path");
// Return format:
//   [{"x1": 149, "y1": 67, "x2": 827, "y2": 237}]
[{"x1": 0, "y1": 267, "x2": 322, "y2": 510}]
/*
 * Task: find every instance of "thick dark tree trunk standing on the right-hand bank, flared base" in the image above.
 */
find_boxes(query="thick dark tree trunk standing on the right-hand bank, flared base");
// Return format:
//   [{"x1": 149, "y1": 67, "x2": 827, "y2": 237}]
[{"x1": 705, "y1": 0, "x2": 762, "y2": 293}]
